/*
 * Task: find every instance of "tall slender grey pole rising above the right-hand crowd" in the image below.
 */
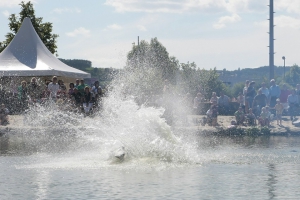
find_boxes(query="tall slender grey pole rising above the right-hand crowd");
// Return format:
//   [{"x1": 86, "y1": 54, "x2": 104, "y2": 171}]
[{"x1": 269, "y1": 0, "x2": 274, "y2": 80}]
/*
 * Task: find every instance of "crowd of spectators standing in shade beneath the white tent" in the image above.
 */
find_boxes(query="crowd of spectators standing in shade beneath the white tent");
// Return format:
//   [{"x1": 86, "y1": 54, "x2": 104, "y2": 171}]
[{"x1": 0, "y1": 76, "x2": 104, "y2": 125}]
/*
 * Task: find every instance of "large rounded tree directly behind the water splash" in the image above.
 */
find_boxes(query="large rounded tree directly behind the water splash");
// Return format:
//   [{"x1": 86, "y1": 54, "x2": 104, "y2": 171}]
[{"x1": 124, "y1": 38, "x2": 179, "y2": 103}]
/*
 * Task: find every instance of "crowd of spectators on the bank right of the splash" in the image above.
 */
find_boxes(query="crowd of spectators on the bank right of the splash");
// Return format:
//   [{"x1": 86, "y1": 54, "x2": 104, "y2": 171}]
[{"x1": 194, "y1": 79, "x2": 300, "y2": 126}]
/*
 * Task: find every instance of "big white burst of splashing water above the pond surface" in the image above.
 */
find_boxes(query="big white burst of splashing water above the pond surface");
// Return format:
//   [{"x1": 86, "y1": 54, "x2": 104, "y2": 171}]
[{"x1": 1, "y1": 72, "x2": 197, "y2": 167}]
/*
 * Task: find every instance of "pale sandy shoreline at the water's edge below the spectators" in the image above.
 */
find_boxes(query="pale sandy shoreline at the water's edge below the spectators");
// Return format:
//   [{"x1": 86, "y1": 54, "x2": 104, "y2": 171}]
[{"x1": 0, "y1": 115, "x2": 300, "y2": 136}]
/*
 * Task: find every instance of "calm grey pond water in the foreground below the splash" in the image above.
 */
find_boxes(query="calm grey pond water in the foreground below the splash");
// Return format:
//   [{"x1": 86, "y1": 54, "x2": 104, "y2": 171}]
[{"x1": 0, "y1": 132, "x2": 300, "y2": 199}]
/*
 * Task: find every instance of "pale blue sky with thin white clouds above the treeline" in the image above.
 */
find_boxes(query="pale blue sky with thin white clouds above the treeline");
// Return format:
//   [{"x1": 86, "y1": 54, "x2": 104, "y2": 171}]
[{"x1": 0, "y1": 0, "x2": 300, "y2": 70}]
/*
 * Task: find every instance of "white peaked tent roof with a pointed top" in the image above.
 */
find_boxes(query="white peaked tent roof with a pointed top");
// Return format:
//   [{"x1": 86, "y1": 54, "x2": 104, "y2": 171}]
[{"x1": 0, "y1": 17, "x2": 91, "y2": 78}]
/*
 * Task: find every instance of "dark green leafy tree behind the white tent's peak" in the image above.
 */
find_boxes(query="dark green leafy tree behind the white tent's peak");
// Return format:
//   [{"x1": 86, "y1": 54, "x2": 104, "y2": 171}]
[{"x1": 0, "y1": 1, "x2": 58, "y2": 54}]
